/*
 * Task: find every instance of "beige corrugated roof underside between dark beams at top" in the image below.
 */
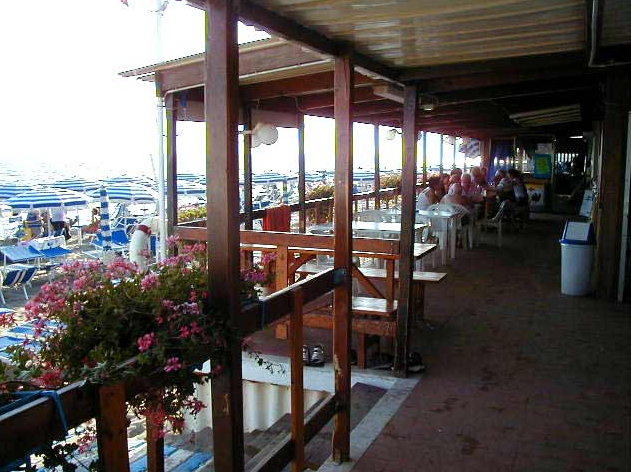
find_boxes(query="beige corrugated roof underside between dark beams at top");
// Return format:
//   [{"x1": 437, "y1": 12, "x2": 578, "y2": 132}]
[{"x1": 253, "y1": 0, "x2": 585, "y2": 67}]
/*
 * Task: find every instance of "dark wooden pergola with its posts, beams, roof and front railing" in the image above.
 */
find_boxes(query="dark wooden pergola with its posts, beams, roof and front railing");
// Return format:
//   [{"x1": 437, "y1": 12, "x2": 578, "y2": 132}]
[{"x1": 0, "y1": 0, "x2": 631, "y2": 472}]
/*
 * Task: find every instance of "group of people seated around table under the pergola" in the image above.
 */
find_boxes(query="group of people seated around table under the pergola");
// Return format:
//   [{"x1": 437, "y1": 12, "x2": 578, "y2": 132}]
[{"x1": 416, "y1": 167, "x2": 528, "y2": 216}]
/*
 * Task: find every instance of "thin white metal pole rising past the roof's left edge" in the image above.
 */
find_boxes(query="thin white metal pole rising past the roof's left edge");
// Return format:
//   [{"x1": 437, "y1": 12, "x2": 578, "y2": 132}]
[{"x1": 156, "y1": 0, "x2": 168, "y2": 261}]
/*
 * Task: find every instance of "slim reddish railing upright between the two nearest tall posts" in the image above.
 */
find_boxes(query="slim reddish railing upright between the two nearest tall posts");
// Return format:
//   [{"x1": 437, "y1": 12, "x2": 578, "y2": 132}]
[{"x1": 290, "y1": 288, "x2": 305, "y2": 472}]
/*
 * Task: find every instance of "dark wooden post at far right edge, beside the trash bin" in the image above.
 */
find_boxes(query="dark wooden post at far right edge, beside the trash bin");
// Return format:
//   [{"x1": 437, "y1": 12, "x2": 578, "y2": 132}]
[{"x1": 595, "y1": 72, "x2": 631, "y2": 300}]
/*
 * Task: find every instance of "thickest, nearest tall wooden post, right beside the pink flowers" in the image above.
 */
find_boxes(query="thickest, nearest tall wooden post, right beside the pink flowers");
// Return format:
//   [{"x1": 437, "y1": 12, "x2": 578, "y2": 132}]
[{"x1": 204, "y1": 0, "x2": 243, "y2": 472}]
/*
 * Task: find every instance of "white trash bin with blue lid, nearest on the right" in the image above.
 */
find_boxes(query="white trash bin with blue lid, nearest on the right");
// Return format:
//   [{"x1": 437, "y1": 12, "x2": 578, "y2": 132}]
[{"x1": 559, "y1": 221, "x2": 595, "y2": 297}]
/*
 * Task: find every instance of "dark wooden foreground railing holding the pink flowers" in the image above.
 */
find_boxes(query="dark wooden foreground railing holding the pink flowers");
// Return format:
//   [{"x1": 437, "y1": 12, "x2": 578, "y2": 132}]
[{"x1": 0, "y1": 269, "x2": 348, "y2": 472}]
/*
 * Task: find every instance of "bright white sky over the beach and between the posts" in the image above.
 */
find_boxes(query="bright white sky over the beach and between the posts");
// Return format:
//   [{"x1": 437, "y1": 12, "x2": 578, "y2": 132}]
[{"x1": 0, "y1": 0, "x2": 474, "y2": 181}]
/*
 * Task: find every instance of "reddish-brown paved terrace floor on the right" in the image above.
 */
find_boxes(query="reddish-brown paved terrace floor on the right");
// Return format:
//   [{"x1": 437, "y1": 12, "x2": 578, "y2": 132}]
[{"x1": 353, "y1": 217, "x2": 631, "y2": 472}]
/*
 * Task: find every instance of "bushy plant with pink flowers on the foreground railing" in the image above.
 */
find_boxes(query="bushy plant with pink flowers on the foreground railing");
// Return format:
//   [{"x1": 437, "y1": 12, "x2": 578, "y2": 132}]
[{"x1": 0, "y1": 240, "x2": 276, "y2": 468}]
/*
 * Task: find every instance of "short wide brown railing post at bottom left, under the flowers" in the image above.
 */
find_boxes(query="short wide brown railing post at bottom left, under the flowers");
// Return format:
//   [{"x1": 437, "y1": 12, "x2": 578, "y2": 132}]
[{"x1": 96, "y1": 383, "x2": 129, "y2": 472}]
